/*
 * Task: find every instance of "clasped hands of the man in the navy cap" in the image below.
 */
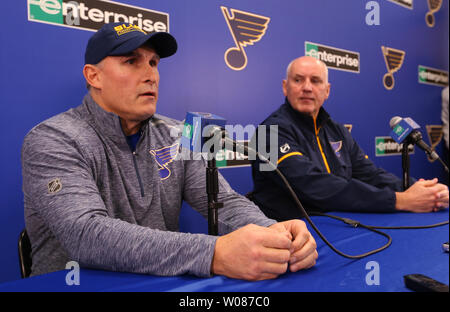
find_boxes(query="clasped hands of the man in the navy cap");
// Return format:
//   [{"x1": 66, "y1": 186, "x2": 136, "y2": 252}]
[{"x1": 211, "y1": 220, "x2": 318, "y2": 281}]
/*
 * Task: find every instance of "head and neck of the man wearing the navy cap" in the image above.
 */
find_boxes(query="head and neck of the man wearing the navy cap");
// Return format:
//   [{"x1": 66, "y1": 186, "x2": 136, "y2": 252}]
[{"x1": 83, "y1": 23, "x2": 177, "y2": 136}]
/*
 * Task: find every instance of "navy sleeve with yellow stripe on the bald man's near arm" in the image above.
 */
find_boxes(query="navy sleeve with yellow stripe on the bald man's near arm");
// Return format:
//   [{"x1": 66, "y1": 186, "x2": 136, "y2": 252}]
[{"x1": 261, "y1": 124, "x2": 395, "y2": 212}]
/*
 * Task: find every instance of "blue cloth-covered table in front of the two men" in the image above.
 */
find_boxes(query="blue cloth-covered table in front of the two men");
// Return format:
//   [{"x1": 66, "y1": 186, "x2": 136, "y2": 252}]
[{"x1": 0, "y1": 209, "x2": 449, "y2": 292}]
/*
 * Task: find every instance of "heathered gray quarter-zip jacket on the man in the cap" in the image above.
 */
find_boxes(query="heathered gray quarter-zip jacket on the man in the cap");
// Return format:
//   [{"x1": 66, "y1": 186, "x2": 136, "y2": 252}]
[{"x1": 22, "y1": 94, "x2": 275, "y2": 276}]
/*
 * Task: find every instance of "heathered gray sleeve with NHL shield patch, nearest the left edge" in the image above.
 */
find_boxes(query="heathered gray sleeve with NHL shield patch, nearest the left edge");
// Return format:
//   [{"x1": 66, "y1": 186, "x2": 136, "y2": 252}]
[{"x1": 22, "y1": 125, "x2": 216, "y2": 276}]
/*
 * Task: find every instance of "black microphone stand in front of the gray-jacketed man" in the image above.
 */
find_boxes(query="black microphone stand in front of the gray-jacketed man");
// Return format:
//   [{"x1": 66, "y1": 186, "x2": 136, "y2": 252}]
[{"x1": 206, "y1": 147, "x2": 223, "y2": 236}]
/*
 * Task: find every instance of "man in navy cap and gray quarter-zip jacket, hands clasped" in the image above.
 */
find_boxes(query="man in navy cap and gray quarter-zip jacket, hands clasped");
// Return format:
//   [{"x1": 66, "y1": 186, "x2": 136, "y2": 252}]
[{"x1": 22, "y1": 23, "x2": 317, "y2": 280}]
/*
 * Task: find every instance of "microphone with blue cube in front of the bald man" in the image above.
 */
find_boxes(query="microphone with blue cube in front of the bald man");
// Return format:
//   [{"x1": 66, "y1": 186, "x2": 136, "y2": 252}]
[{"x1": 389, "y1": 116, "x2": 439, "y2": 160}]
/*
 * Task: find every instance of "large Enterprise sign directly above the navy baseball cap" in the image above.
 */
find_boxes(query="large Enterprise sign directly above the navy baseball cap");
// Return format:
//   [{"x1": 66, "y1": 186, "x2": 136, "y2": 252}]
[{"x1": 28, "y1": 0, "x2": 169, "y2": 33}]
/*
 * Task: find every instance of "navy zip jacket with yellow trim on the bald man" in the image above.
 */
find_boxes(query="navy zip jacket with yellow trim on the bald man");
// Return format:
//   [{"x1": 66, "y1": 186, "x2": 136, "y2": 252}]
[{"x1": 252, "y1": 99, "x2": 402, "y2": 221}]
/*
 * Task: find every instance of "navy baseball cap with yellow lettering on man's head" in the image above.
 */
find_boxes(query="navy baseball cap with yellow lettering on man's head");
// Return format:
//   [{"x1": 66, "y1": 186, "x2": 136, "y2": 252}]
[{"x1": 84, "y1": 22, "x2": 178, "y2": 64}]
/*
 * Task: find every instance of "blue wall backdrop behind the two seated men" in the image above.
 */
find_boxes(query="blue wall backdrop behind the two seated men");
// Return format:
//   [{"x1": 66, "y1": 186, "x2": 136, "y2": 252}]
[{"x1": 0, "y1": 0, "x2": 449, "y2": 282}]
